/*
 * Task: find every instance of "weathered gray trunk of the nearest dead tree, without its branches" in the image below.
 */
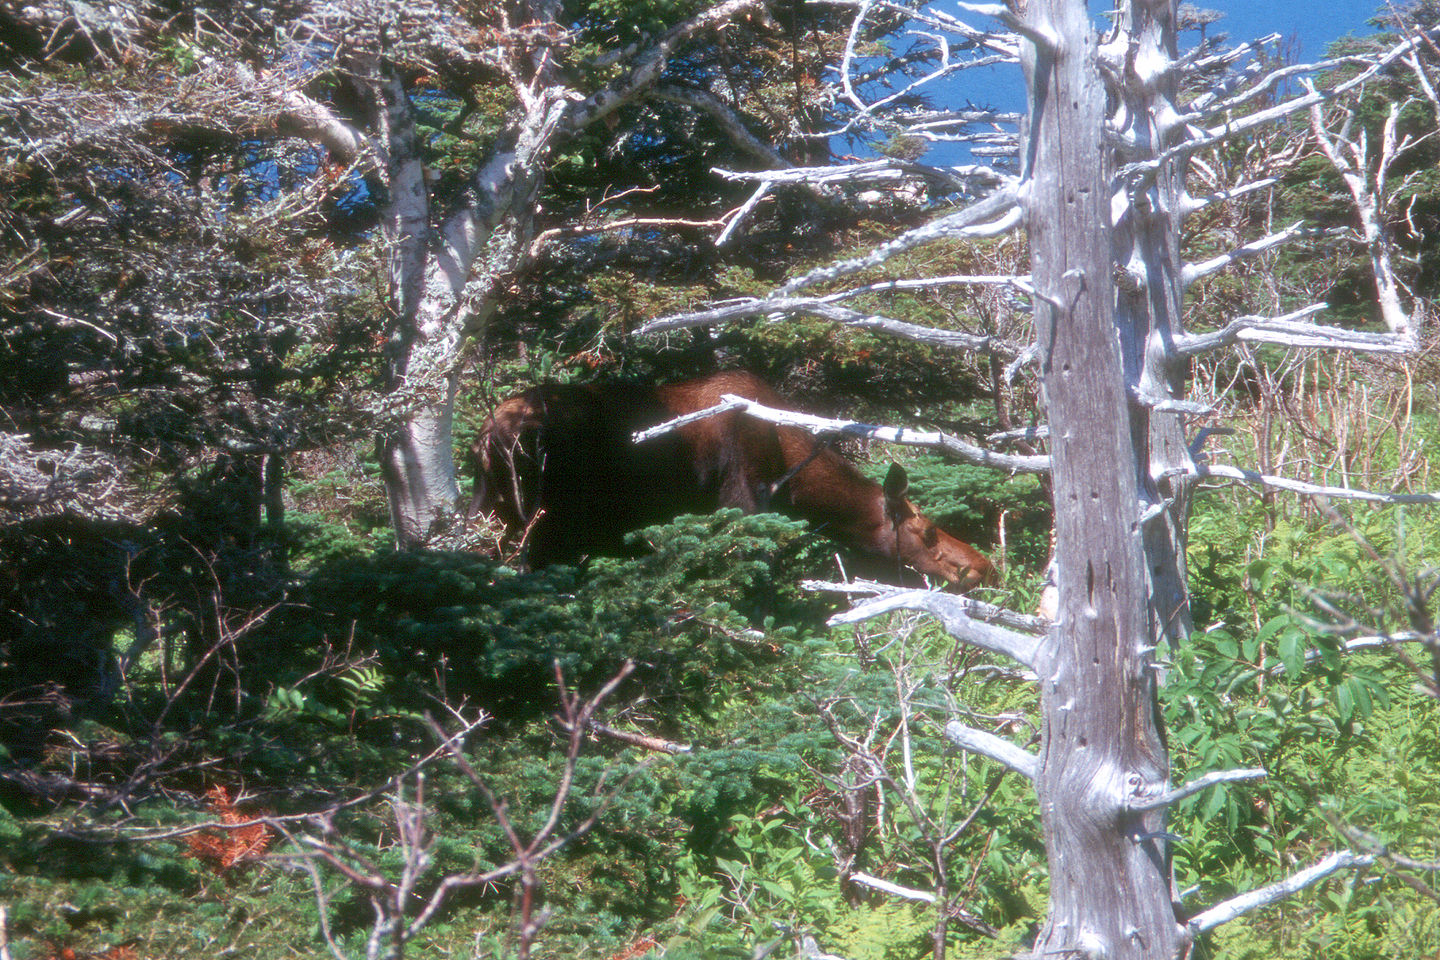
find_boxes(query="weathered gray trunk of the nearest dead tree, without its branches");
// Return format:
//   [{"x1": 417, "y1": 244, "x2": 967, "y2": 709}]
[{"x1": 1024, "y1": 0, "x2": 1182, "y2": 960}]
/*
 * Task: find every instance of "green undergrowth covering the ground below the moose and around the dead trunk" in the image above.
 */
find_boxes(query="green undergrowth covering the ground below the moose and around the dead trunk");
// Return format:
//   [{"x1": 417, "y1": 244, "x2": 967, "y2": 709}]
[{"x1": 0, "y1": 417, "x2": 1440, "y2": 960}]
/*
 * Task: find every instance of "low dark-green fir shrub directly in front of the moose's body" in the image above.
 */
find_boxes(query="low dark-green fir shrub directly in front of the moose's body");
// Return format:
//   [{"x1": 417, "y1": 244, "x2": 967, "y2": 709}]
[{"x1": 252, "y1": 511, "x2": 824, "y2": 718}]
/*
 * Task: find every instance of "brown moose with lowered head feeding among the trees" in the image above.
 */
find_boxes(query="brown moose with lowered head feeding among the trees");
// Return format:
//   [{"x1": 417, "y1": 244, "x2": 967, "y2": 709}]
[{"x1": 469, "y1": 371, "x2": 994, "y2": 590}]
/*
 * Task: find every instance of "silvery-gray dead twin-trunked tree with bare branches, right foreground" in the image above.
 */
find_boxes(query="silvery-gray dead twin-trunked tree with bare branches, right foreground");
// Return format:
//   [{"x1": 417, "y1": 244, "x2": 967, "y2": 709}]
[{"x1": 644, "y1": 0, "x2": 1440, "y2": 960}]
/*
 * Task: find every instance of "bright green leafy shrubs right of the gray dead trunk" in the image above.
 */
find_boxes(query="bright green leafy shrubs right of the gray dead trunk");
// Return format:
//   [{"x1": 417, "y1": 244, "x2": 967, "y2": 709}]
[{"x1": 1162, "y1": 497, "x2": 1440, "y2": 959}]
